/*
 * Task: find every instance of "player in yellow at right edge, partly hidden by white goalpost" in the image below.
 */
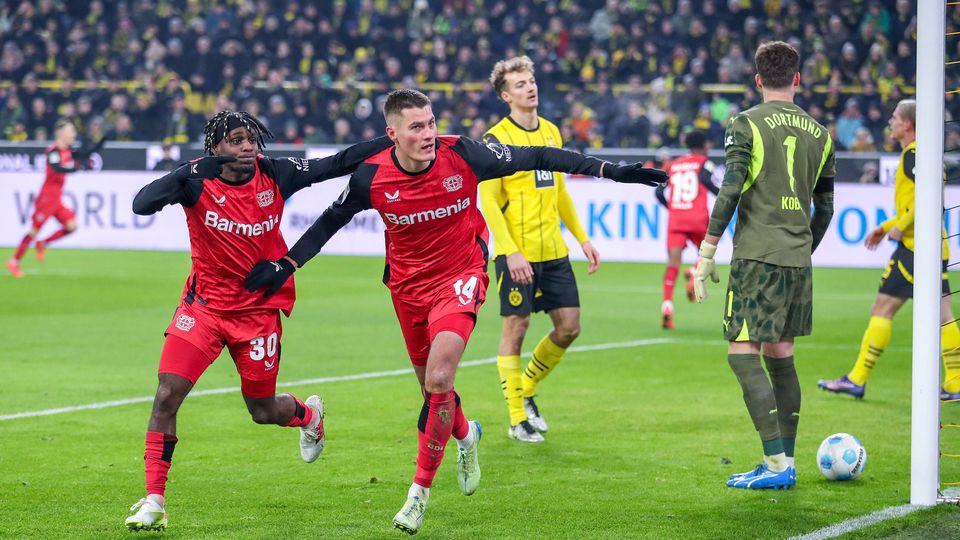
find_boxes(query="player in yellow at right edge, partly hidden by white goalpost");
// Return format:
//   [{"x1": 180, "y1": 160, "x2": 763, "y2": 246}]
[{"x1": 817, "y1": 99, "x2": 960, "y2": 401}]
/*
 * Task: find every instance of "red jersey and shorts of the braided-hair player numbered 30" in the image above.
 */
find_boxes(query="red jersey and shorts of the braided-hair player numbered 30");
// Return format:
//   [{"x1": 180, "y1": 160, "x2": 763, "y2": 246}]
[{"x1": 133, "y1": 137, "x2": 392, "y2": 398}]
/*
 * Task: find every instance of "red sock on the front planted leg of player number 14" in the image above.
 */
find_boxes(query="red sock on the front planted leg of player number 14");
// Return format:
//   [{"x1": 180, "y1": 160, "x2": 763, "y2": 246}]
[{"x1": 413, "y1": 390, "x2": 458, "y2": 487}]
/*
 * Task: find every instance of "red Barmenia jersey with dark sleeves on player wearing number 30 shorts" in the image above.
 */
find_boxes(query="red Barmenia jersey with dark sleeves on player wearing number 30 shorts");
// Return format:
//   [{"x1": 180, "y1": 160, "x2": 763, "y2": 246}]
[{"x1": 133, "y1": 137, "x2": 393, "y2": 315}]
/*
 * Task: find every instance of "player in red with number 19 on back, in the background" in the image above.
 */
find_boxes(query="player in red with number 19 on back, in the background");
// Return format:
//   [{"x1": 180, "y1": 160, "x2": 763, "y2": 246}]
[{"x1": 657, "y1": 131, "x2": 720, "y2": 330}]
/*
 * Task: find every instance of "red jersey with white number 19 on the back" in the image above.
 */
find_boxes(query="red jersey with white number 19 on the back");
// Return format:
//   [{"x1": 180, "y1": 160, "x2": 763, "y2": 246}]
[{"x1": 664, "y1": 154, "x2": 713, "y2": 231}]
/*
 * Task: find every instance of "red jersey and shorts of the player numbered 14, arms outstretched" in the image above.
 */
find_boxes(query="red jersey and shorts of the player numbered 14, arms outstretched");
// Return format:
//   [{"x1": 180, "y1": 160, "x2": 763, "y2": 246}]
[{"x1": 288, "y1": 136, "x2": 602, "y2": 365}]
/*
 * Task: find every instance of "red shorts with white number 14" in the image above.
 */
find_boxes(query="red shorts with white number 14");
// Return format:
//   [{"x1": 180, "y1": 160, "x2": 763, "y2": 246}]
[{"x1": 393, "y1": 271, "x2": 490, "y2": 366}]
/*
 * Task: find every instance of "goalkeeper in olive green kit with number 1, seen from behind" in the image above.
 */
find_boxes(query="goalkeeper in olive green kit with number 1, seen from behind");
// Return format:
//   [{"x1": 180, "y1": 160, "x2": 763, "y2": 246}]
[{"x1": 694, "y1": 41, "x2": 835, "y2": 489}]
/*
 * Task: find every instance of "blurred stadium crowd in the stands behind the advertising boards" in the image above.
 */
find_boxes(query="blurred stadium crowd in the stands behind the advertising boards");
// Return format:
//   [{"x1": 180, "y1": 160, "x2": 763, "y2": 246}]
[{"x1": 0, "y1": 0, "x2": 944, "y2": 151}]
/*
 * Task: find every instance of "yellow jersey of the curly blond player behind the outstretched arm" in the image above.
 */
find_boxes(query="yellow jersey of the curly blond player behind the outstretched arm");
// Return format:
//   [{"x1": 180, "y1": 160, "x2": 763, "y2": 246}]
[{"x1": 480, "y1": 116, "x2": 589, "y2": 262}]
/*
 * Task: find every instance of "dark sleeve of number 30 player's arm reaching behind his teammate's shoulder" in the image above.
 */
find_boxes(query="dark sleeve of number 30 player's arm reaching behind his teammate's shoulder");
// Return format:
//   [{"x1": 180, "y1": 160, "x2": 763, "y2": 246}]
[{"x1": 270, "y1": 136, "x2": 393, "y2": 199}]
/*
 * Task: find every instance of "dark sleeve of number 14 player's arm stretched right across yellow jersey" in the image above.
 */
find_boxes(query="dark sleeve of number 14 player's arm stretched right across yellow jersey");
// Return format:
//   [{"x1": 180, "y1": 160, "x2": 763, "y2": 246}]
[{"x1": 452, "y1": 137, "x2": 603, "y2": 180}]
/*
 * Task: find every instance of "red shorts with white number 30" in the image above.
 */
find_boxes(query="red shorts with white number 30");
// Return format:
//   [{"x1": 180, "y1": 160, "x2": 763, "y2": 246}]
[{"x1": 158, "y1": 302, "x2": 283, "y2": 398}]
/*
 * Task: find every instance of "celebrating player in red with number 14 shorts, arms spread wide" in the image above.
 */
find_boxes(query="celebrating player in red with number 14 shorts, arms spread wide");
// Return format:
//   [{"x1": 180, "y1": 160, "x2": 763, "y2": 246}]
[{"x1": 246, "y1": 89, "x2": 666, "y2": 534}]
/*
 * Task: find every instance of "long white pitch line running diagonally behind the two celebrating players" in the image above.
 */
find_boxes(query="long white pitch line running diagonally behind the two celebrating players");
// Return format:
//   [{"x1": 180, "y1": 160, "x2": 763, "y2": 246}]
[{"x1": 0, "y1": 338, "x2": 675, "y2": 421}]
